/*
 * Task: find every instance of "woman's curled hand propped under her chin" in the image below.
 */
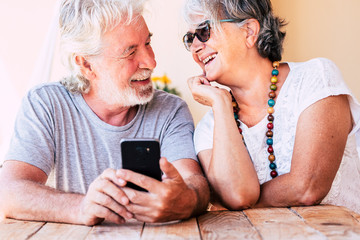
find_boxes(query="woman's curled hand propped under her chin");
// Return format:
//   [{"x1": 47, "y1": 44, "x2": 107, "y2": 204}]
[{"x1": 188, "y1": 75, "x2": 231, "y2": 107}]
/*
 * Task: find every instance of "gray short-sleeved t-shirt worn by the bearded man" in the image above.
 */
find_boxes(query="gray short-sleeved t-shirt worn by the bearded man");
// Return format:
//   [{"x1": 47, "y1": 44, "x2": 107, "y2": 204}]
[{"x1": 5, "y1": 83, "x2": 197, "y2": 193}]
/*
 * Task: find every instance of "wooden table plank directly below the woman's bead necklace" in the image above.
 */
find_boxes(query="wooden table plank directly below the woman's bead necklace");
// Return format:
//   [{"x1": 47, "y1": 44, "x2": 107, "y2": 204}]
[{"x1": 244, "y1": 208, "x2": 326, "y2": 240}]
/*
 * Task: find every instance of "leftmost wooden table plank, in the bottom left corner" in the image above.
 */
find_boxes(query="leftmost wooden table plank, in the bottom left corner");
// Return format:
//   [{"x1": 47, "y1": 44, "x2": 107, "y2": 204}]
[{"x1": 0, "y1": 218, "x2": 45, "y2": 240}]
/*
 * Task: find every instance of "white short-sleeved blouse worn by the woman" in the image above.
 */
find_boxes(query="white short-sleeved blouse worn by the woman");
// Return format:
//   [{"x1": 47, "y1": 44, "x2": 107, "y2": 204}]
[{"x1": 194, "y1": 58, "x2": 360, "y2": 213}]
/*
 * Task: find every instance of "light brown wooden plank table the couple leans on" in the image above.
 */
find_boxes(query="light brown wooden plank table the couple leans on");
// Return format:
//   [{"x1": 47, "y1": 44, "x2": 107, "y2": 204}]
[{"x1": 0, "y1": 205, "x2": 360, "y2": 240}]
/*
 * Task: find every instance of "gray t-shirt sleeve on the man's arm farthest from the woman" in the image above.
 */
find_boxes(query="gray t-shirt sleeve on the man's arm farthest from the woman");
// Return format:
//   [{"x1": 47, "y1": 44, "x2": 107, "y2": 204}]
[{"x1": 5, "y1": 88, "x2": 55, "y2": 175}]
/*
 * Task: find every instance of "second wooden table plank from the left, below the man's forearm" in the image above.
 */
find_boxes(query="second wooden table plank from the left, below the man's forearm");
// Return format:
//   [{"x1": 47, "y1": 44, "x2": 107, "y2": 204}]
[{"x1": 31, "y1": 223, "x2": 91, "y2": 240}]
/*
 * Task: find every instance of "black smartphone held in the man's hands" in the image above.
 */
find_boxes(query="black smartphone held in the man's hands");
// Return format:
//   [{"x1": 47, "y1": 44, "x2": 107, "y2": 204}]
[{"x1": 120, "y1": 138, "x2": 162, "y2": 191}]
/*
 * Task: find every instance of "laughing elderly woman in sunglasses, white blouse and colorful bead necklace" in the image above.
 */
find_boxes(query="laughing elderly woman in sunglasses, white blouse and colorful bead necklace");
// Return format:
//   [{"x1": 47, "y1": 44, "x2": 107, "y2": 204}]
[{"x1": 183, "y1": 0, "x2": 360, "y2": 213}]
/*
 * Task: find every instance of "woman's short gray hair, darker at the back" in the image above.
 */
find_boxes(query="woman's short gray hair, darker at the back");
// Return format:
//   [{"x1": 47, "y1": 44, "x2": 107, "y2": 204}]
[{"x1": 183, "y1": 0, "x2": 286, "y2": 61}]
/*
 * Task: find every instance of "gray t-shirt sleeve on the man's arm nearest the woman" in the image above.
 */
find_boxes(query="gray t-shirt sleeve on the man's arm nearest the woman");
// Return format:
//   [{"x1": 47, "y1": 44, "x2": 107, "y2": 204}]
[{"x1": 161, "y1": 100, "x2": 198, "y2": 162}]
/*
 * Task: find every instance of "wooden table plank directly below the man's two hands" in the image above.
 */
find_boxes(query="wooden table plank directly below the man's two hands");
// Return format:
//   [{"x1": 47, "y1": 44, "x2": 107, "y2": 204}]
[{"x1": 86, "y1": 220, "x2": 144, "y2": 240}]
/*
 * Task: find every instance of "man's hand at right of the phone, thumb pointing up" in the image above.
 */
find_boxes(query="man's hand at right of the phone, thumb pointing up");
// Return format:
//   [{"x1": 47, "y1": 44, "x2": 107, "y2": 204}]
[{"x1": 117, "y1": 158, "x2": 198, "y2": 222}]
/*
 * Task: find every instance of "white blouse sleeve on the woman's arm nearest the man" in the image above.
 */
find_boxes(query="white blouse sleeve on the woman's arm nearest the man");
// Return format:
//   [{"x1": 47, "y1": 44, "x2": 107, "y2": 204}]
[{"x1": 194, "y1": 110, "x2": 214, "y2": 154}]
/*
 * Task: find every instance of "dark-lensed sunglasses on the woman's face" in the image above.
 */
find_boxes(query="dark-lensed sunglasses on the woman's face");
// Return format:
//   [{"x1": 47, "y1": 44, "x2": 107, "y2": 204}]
[{"x1": 183, "y1": 19, "x2": 243, "y2": 51}]
